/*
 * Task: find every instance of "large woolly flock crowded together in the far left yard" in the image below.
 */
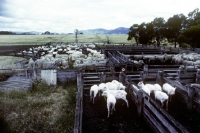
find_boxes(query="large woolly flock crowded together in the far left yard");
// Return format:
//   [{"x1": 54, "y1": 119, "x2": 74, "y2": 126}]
[{"x1": 26, "y1": 44, "x2": 107, "y2": 69}]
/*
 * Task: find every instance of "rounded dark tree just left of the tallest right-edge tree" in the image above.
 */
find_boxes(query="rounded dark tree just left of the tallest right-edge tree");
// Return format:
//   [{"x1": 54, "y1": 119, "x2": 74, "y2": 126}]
[{"x1": 165, "y1": 14, "x2": 187, "y2": 47}]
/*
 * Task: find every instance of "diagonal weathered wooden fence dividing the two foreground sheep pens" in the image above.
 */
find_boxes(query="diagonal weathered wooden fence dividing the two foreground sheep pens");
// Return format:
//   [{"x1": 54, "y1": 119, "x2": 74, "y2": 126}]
[{"x1": 119, "y1": 73, "x2": 188, "y2": 133}]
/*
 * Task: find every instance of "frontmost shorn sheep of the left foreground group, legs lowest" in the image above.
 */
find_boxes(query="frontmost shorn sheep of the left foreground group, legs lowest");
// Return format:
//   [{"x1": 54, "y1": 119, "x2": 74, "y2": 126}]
[{"x1": 102, "y1": 91, "x2": 116, "y2": 117}]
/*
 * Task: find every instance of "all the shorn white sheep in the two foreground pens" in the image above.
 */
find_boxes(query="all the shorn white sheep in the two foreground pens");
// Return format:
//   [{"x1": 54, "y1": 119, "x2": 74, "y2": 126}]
[{"x1": 90, "y1": 80, "x2": 176, "y2": 117}]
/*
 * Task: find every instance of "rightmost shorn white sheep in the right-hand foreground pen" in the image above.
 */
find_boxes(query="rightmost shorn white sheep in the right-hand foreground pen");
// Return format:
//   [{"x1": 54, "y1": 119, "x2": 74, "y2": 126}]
[{"x1": 163, "y1": 83, "x2": 176, "y2": 101}]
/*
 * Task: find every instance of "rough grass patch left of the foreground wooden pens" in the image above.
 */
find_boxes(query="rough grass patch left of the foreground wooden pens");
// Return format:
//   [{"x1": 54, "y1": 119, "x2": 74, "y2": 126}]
[{"x1": 0, "y1": 81, "x2": 77, "y2": 133}]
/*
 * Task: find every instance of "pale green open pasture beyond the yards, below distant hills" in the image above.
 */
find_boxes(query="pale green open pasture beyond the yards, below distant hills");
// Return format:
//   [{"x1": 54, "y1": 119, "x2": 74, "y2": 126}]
[{"x1": 0, "y1": 34, "x2": 135, "y2": 46}]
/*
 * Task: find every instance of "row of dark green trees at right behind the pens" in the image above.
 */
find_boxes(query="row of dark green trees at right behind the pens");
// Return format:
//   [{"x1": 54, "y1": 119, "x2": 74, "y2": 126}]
[{"x1": 127, "y1": 8, "x2": 200, "y2": 48}]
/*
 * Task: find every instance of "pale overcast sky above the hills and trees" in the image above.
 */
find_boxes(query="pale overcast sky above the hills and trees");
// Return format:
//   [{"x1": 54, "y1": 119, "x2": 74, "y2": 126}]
[{"x1": 0, "y1": 0, "x2": 200, "y2": 33}]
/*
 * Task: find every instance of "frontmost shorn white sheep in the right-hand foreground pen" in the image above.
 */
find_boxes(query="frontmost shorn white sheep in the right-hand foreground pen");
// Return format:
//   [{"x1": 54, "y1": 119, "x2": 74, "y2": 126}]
[{"x1": 154, "y1": 91, "x2": 169, "y2": 110}]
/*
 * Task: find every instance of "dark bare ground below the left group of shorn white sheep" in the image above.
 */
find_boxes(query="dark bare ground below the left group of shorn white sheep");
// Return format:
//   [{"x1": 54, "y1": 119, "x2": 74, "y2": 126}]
[{"x1": 82, "y1": 94, "x2": 152, "y2": 133}]
